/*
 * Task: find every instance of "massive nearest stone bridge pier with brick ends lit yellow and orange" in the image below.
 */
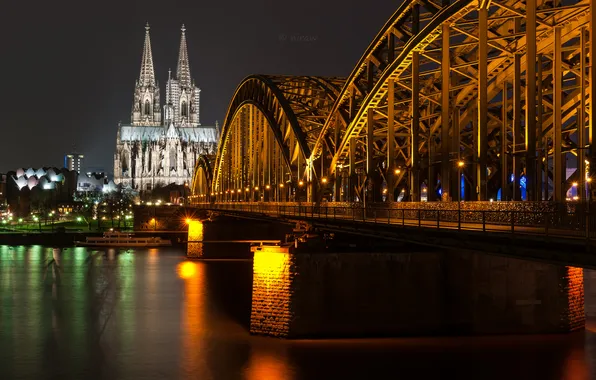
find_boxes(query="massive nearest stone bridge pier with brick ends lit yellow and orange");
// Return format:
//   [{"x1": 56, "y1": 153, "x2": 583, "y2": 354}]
[{"x1": 250, "y1": 247, "x2": 585, "y2": 338}]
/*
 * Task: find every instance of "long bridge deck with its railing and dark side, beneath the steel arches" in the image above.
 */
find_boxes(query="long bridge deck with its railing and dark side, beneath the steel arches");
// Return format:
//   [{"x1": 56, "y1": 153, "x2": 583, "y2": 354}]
[{"x1": 190, "y1": 202, "x2": 596, "y2": 268}]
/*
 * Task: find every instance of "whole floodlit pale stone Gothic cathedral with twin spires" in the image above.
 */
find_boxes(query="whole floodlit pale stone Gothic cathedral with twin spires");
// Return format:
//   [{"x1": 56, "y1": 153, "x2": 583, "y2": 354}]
[{"x1": 114, "y1": 25, "x2": 219, "y2": 191}]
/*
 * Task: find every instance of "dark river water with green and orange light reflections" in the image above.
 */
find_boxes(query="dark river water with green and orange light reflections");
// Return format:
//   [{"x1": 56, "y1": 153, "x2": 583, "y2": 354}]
[{"x1": 0, "y1": 246, "x2": 596, "y2": 380}]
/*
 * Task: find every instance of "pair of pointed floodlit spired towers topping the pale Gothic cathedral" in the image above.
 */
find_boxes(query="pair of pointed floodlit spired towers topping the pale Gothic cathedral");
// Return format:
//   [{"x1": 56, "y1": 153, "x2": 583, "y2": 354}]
[{"x1": 132, "y1": 23, "x2": 200, "y2": 126}]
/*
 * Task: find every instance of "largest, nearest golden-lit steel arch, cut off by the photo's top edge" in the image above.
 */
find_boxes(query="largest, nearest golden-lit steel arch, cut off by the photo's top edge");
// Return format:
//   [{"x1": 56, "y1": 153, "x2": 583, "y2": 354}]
[{"x1": 309, "y1": 0, "x2": 591, "y2": 202}]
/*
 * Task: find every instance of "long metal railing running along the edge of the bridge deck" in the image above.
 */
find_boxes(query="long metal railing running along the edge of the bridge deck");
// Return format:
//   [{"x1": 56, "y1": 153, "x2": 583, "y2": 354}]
[{"x1": 196, "y1": 202, "x2": 596, "y2": 238}]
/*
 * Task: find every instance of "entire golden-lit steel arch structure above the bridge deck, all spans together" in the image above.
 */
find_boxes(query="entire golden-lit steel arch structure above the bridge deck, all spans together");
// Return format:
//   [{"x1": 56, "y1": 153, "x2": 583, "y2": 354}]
[{"x1": 193, "y1": 0, "x2": 596, "y2": 202}]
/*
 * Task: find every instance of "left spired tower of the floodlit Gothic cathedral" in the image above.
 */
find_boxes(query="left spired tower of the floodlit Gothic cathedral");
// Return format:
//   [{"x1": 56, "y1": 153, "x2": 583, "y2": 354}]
[{"x1": 131, "y1": 24, "x2": 161, "y2": 126}]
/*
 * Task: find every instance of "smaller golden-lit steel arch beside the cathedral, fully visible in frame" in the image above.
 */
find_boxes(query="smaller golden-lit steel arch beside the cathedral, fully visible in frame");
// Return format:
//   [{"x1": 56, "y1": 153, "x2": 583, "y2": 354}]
[{"x1": 210, "y1": 75, "x2": 343, "y2": 200}]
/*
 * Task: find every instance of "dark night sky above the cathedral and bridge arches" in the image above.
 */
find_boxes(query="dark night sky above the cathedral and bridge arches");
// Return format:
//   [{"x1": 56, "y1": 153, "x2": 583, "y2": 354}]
[{"x1": 0, "y1": 0, "x2": 400, "y2": 172}]
